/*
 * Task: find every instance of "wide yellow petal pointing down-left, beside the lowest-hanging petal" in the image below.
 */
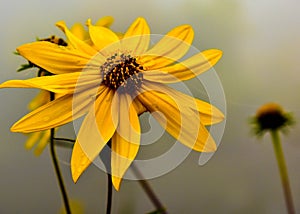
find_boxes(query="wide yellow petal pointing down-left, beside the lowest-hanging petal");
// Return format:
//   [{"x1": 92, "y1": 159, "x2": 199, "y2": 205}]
[{"x1": 71, "y1": 88, "x2": 118, "y2": 182}]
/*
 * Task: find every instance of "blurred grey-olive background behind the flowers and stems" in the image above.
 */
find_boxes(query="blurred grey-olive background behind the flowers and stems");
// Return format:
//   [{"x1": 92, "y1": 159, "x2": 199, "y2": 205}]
[{"x1": 0, "y1": 0, "x2": 300, "y2": 214}]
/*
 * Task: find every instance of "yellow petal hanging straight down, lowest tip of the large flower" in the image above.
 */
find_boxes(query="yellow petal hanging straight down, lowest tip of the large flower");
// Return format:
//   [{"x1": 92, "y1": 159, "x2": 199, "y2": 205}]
[{"x1": 111, "y1": 94, "x2": 140, "y2": 190}]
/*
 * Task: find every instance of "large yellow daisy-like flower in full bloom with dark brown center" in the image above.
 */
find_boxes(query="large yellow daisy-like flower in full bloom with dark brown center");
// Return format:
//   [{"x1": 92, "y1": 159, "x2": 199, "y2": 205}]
[{"x1": 0, "y1": 18, "x2": 224, "y2": 190}]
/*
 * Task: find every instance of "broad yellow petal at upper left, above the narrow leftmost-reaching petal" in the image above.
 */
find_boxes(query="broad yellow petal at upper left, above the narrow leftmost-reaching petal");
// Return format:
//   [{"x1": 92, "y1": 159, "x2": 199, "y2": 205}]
[{"x1": 17, "y1": 41, "x2": 90, "y2": 74}]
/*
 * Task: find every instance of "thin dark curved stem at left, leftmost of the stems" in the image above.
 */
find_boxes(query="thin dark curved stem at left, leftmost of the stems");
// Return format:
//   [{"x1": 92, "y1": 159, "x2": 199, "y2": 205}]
[{"x1": 50, "y1": 92, "x2": 71, "y2": 214}]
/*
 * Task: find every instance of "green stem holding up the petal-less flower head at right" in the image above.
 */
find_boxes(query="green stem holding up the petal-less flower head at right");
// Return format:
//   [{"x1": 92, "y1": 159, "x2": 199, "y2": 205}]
[{"x1": 271, "y1": 130, "x2": 295, "y2": 214}]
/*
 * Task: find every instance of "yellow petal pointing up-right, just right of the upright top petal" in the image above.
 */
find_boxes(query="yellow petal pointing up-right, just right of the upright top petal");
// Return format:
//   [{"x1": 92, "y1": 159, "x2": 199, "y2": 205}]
[{"x1": 139, "y1": 25, "x2": 194, "y2": 70}]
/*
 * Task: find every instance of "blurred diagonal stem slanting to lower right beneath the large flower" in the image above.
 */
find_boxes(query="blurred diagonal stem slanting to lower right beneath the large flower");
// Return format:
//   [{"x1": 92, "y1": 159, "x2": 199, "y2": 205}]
[{"x1": 131, "y1": 163, "x2": 167, "y2": 214}]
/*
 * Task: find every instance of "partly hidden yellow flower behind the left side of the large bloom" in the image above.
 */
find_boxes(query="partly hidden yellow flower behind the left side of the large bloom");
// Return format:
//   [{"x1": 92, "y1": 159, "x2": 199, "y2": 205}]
[{"x1": 25, "y1": 16, "x2": 114, "y2": 156}]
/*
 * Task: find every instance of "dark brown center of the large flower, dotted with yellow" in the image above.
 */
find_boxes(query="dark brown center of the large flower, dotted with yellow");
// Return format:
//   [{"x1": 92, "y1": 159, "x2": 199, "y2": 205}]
[{"x1": 100, "y1": 53, "x2": 143, "y2": 93}]
